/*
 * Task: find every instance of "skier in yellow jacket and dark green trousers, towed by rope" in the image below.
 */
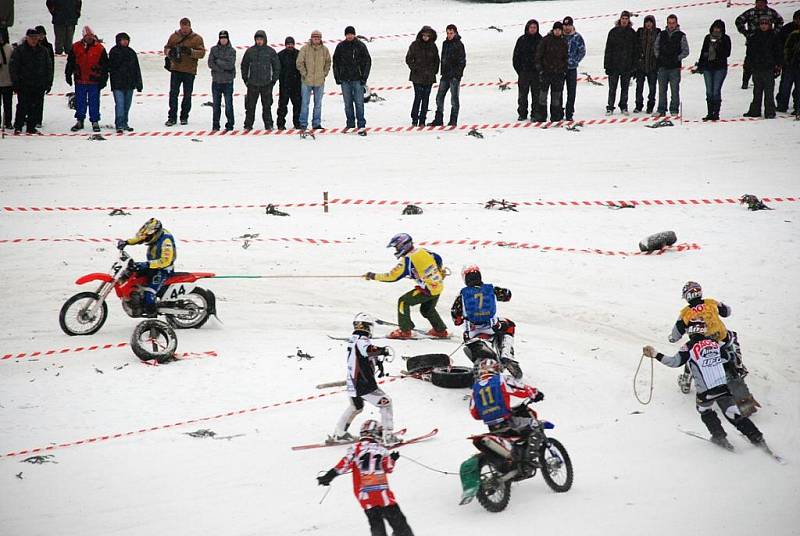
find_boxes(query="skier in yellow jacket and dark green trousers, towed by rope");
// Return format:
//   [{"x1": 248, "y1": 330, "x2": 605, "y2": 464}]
[{"x1": 364, "y1": 233, "x2": 449, "y2": 339}]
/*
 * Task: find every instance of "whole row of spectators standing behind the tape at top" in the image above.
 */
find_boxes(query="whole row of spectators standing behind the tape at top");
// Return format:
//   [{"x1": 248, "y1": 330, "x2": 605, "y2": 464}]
[{"x1": 0, "y1": 0, "x2": 800, "y2": 135}]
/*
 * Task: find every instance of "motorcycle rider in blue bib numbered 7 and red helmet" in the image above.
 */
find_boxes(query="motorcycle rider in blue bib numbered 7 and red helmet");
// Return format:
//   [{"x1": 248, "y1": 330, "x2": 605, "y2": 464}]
[{"x1": 450, "y1": 264, "x2": 522, "y2": 379}]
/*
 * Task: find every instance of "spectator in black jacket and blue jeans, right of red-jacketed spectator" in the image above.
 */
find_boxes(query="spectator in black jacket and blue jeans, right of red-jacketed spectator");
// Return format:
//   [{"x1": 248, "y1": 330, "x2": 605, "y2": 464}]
[{"x1": 108, "y1": 32, "x2": 142, "y2": 134}]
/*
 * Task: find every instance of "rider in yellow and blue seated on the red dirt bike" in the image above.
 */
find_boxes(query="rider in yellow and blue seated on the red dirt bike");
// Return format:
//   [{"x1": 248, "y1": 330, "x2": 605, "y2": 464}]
[{"x1": 117, "y1": 218, "x2": 177, "y2": 317}]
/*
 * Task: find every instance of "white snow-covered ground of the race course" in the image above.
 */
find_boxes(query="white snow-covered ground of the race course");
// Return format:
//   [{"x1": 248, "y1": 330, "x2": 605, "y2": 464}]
[{"x1": 0, "y1": 0, "x2": 800, "y2": 536}]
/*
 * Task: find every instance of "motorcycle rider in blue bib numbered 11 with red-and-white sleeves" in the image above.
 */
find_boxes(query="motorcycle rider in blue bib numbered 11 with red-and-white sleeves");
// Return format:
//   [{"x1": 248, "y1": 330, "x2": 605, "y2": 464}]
[{"x1": 469, "y1": 359, "x2": 544, "y2": 464}]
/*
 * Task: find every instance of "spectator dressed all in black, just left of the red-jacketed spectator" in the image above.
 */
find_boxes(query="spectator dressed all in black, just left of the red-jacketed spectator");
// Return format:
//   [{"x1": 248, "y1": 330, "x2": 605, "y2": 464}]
[{"x1": 9, "y1": 28, "x2": 53, "y2": 134}]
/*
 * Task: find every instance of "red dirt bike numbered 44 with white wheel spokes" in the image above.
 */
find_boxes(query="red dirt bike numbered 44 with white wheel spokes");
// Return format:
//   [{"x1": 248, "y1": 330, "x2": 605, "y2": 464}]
[{"x1": 58, "y1": 251, "x2": 217, "y2": 335}]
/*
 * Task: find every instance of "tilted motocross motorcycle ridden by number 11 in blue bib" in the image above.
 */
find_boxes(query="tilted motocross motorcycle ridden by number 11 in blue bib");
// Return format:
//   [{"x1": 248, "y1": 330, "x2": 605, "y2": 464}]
[{"x1": 460, "y1": 398, "x2": 573, "y2": 512}]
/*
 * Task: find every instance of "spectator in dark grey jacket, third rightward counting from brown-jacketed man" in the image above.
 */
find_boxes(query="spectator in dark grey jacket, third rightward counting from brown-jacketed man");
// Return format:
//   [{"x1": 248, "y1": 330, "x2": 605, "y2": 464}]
[{"x1": 242, "y1": 30, "x2": 281, "y2": 130}]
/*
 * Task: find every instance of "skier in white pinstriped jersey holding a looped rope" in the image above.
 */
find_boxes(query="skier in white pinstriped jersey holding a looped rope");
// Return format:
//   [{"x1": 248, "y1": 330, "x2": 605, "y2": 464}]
[{"x1": 642, "y1": 318, "x2": 765, "y2": 450}]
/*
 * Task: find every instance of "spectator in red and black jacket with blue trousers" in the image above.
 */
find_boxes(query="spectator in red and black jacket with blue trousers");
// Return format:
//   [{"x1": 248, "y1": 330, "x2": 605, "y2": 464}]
[{"x1": 64, "y1": 26, "x2": 108, "y2": 132}]
